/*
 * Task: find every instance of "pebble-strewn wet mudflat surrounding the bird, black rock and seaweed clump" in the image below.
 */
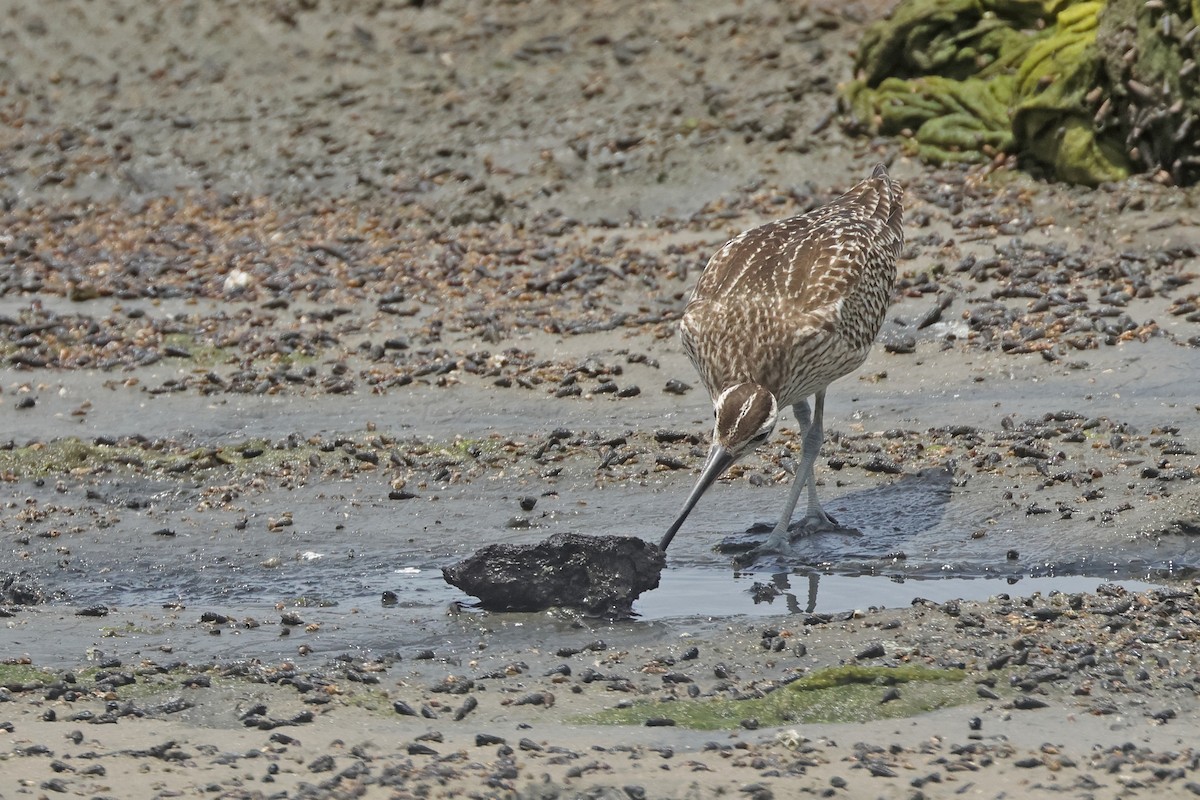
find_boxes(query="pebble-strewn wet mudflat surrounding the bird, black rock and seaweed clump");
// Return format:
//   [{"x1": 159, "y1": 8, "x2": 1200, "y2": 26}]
[{"x1": 0, "y1": 0, "x2": 1200, "y2": 798}]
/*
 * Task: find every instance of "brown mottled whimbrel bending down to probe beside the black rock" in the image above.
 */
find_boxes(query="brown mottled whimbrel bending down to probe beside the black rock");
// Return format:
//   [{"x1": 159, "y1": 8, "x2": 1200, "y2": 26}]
[{"x1": 661, "y1": 164, "x2": 904, "y2": 553}]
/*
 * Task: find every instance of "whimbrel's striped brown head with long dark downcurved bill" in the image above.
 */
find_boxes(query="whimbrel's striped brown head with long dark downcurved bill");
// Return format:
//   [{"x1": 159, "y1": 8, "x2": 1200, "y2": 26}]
[{"x1": 660, "y1": 383, "x2": 779, "y2": 549}]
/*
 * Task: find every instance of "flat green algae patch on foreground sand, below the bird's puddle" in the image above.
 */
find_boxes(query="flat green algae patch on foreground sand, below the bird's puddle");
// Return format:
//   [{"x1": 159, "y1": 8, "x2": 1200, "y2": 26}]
[{"x1": 577, "y1": 666, "x2": 976, "y2": 730}]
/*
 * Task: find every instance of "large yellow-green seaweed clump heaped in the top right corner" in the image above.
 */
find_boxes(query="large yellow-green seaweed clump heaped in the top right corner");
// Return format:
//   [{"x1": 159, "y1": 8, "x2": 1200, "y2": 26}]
[{"x1": 844, "y1": 0, "x2": 1200, "y2": 186}]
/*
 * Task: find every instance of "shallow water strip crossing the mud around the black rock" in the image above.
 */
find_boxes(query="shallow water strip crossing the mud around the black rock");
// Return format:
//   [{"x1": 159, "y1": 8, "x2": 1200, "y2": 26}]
[{"x1": 14, "y1": 470, "x2": 1200, "y2": 620}]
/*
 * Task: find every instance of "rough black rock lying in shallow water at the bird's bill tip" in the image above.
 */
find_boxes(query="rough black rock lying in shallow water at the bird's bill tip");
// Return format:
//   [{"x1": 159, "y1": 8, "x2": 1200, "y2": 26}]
[{"x1": 442, "y1": 534, "x2": 666, "y2": 616}]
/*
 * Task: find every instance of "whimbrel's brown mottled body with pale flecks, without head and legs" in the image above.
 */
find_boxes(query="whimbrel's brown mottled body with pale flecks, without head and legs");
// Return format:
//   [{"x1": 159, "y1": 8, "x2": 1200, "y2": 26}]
[{"x1": 680, "y1": 166, "x2": 904, "y2": 407}]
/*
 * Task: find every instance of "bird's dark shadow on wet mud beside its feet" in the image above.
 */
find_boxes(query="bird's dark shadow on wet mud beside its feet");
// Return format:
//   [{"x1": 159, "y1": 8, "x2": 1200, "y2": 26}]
[{"x1": 715, "y1": 469, "x2": 954, "y2": 572}]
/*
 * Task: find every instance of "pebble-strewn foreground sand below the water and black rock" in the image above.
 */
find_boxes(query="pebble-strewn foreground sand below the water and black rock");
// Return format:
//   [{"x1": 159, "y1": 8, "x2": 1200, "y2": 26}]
[{"x1": 2, "y1": 590, "x2": 1198, "y2": 798}]
